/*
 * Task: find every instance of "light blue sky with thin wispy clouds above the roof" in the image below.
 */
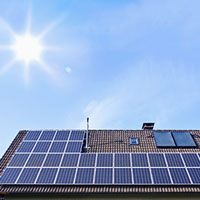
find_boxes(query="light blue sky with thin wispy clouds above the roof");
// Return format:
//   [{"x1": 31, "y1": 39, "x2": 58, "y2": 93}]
[{"x1": 0, "y1": 0, "x2": 200, "y2": 157}]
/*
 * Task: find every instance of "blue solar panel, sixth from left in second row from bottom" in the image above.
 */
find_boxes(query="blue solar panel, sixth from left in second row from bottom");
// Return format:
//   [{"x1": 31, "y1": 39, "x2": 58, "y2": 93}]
[{"x1": 97, "y1": 154, "x2": 113, "y2": 167}]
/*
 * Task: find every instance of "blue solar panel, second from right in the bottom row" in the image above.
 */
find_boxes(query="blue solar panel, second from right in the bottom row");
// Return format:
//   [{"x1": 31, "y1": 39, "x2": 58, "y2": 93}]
[{"x1": 169, "y1": 168, "x2": 190, "y2": 184}]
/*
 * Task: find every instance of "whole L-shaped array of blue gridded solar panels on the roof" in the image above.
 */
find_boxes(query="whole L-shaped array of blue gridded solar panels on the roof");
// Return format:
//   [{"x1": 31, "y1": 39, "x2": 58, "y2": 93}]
[{"x1": 0, "y1": 131, "x2": 200, "y2": 185}]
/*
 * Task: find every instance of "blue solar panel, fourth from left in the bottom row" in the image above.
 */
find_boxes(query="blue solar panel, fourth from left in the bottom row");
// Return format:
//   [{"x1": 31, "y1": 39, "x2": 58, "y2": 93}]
[{"x1": 56, "y1": 168, "x2": 76, "y2": 184}]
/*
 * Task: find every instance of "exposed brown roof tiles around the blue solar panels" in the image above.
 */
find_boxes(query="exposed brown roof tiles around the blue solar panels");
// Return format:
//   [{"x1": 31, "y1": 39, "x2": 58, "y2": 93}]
[{"x1": 0, "y1": 130, "x2": 200, "y2": 197}]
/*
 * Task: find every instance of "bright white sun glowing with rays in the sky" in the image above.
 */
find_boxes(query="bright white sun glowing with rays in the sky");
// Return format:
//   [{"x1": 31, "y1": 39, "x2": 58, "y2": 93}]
[{"x1": 11, "y1": 32, "x2": 44, "y2": 65}]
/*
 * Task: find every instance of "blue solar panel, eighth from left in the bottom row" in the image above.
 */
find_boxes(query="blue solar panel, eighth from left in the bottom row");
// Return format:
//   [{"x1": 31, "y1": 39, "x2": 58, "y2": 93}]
[{"x1": 133, "y1": 168, "x2": 152, "y2": 184}]
